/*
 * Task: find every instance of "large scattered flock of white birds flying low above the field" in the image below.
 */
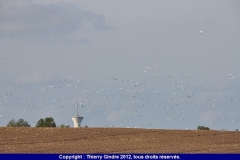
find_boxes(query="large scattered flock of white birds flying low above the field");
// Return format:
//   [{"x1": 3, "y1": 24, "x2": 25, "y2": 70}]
[{"x1": 0, "y1": 61, "x2": 240, "y2": 129}]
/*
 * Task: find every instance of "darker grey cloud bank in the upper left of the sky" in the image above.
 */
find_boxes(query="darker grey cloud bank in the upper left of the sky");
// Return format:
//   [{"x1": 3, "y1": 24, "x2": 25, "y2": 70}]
[{"x1": 0, "y1": 1, "x2": 111, "y2": 36}]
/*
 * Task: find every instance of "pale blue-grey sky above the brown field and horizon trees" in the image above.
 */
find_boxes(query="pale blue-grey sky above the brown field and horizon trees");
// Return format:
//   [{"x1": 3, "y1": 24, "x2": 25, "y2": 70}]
[{"x1": 0, "y1": 0, "x2": 240, "y2": 130}]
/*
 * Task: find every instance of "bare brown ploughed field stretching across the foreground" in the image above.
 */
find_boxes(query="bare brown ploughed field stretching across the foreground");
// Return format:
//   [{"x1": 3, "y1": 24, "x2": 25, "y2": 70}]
[{"x1": 0, "y1": 127, "x2": 240, "y2": 153}]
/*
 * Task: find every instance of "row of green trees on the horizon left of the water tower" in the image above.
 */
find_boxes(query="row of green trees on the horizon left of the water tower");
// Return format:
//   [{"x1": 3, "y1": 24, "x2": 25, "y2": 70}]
[{"x1": 6, "y1": 117, "x2": 70, "y2": 128}]
